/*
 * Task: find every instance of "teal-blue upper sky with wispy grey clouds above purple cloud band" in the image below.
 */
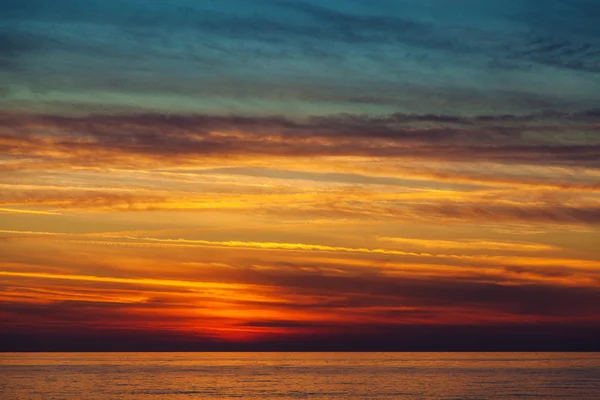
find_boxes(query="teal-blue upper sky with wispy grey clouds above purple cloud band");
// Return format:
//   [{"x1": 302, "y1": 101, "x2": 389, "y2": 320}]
[{"x1": 0, "y1": 0, "x2": 600, "y2": 117}]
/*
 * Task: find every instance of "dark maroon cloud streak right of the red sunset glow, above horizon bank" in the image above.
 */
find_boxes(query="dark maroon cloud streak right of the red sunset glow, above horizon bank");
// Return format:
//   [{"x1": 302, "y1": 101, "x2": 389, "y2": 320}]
[{"x1": 264, "y1": 274, "x2": 600, "y2": 317}]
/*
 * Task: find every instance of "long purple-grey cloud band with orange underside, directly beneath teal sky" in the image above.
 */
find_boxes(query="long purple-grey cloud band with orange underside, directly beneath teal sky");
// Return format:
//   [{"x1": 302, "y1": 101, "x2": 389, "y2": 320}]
[{"x1": 2, "y1": 110, "x2": 600, "y2": 168}]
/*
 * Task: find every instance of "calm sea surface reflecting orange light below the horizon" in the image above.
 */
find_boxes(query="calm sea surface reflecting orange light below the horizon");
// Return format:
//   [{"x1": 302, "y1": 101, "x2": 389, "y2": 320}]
[{"x1": 0, "y1": 353, "x2": 600, "y2": 400}]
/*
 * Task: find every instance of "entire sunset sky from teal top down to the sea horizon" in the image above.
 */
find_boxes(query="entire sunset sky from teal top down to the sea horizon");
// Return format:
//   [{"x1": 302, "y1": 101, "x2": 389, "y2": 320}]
[{"x1": 0, "y1": 0, "x2": 600, "y2": 351}]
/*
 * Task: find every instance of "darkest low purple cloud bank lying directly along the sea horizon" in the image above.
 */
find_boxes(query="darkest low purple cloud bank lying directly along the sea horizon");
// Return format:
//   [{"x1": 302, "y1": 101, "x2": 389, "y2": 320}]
[{"x1": 0, "y1": 323, "x2": 600, "y2": 351}]
